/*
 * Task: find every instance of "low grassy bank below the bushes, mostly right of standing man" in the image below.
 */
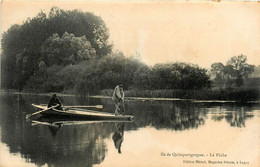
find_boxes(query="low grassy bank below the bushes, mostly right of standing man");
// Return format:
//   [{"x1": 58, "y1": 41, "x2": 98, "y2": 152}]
[{"x1": 101, "y1": 89, "x2": 260, "y2": 102}]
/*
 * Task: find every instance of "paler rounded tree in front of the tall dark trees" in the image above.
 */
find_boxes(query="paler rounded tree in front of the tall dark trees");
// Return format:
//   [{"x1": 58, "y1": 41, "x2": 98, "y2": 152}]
[{"x1": 40, "y1": 32, "x2": 96, "y2": 66}]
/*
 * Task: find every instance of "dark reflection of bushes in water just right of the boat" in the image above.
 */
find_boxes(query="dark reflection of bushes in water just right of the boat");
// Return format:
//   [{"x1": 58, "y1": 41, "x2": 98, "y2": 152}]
[{"x1": 119, "y1": 101, "x2": 207, "y2": 131}]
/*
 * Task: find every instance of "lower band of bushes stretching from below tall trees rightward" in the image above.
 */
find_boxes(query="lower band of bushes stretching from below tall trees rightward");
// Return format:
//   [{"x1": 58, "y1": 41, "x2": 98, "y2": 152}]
[{"x1": 25, "y1": 52, "x2": 210, "y2": 95}]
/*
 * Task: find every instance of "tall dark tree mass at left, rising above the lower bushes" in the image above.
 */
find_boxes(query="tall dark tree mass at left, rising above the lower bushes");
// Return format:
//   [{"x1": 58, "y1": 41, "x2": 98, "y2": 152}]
[{"x1": 1, "y1": 7, "x2": 112, "y2": 90}]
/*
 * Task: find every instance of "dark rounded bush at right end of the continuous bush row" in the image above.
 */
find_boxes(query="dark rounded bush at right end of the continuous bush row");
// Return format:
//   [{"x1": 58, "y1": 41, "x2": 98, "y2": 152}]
[{"x1": 151, "y1": 63, "x2": 210, "y2": 89}]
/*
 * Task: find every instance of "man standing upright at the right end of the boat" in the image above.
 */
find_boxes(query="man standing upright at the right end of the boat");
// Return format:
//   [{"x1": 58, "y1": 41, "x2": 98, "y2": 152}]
[{"x1": 112, "y1": 83, "x2": 125, "y2": 115}]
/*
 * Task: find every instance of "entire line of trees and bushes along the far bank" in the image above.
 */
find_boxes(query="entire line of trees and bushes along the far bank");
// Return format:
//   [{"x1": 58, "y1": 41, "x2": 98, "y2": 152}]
[{"x1": 1, "y1": 7, "x2": 254, "y2": 100}]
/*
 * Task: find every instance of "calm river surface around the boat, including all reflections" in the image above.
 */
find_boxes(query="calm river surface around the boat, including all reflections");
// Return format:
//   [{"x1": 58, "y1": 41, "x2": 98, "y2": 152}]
[{"x1": 0, "y1": 93, "x2": 260, "y2": 167}]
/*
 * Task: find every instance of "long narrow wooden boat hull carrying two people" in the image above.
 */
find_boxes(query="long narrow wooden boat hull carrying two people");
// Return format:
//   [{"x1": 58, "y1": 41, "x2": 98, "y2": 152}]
[{"x1": 32, "y1": 104, "x2": 133, "y2": 120}]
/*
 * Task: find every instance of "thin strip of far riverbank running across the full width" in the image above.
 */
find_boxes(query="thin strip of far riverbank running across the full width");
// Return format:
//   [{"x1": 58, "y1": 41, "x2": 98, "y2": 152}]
[{"x1": 1, "y1": 89, "x2": 260, "y2": 103}]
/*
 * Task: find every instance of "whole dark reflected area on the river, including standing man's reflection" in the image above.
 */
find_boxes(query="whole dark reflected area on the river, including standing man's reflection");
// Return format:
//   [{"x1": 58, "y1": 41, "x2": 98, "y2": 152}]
[{"x1": 0, "y1": 94, "x2": 259, "y2": 167}]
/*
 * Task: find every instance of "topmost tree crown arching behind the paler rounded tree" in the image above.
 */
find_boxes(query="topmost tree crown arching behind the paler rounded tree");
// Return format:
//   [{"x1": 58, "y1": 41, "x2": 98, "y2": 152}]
[{"x1": 47, "y1": 7, "x2": 112, "y2": 57}]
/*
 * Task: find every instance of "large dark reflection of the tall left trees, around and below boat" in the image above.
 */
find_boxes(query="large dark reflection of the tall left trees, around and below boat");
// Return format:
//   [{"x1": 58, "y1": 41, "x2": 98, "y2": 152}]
[{"x1": 0, "y1": 95, "x2": 114, "y2": 166}]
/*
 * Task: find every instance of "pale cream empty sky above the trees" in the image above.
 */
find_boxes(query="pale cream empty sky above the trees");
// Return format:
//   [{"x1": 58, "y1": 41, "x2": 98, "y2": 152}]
[{"x1": 1, "y1": 0, "x2": 260, "y2": 68}]
